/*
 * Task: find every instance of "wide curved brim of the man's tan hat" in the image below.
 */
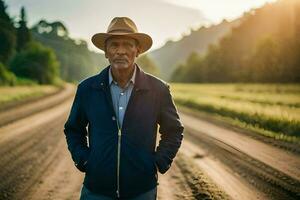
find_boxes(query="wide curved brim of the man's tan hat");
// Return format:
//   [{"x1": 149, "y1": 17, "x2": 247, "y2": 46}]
[{"x1": 92, "y1": 33, "x2": 152, "y2": 53}]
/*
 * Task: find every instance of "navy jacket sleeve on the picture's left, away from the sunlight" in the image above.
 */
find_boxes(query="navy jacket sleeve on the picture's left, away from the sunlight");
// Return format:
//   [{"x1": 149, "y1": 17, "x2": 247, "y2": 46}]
[{"x1": 64, "y1": 85, "x2": 89, "y2": 172}]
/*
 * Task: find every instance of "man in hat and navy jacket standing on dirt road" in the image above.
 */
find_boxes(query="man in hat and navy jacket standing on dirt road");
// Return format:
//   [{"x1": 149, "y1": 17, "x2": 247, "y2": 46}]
[{"x1": 64, "y1": 17, "x2": 183, "y2": 200}]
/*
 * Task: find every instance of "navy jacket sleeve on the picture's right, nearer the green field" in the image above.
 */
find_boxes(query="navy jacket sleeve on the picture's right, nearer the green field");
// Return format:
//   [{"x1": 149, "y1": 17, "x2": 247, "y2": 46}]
[{"x1": 155, "y1": 84, "x2": 184, "y2": 174}]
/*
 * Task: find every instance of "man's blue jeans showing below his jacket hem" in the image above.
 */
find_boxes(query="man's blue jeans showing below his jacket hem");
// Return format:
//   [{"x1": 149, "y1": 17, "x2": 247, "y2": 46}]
[{"x1": 80, "y1": 185, "x2": 157, "y2": 200}]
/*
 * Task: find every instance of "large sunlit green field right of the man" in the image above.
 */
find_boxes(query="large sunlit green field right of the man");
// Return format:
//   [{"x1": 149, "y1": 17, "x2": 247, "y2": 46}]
[{"x1": 171, "y1": 84, "x2": 300, "y2": 142}]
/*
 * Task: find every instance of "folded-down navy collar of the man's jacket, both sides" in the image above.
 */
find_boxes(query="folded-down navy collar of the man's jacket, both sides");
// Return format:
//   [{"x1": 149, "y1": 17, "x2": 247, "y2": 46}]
[{"x1": 91, "y1": 64, "x2": 150, "y2": 91}]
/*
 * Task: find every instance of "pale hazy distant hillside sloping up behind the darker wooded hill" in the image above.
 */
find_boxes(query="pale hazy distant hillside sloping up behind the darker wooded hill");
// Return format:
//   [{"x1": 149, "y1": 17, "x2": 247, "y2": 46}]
[{"x1": 148, "y1": 20, "x2": 239, "y2": 80}]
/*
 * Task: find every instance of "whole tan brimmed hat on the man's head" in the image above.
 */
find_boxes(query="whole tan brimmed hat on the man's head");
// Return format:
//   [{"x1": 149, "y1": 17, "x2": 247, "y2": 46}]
[{"x1": 92, "y1": 17, "x2": 152, "y2": 53}]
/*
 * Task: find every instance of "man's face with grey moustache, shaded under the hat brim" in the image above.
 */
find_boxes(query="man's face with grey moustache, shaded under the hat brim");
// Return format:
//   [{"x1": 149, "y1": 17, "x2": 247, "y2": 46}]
[{"x1": 105, "y1": 36, "x2": 139, "y2": 69}]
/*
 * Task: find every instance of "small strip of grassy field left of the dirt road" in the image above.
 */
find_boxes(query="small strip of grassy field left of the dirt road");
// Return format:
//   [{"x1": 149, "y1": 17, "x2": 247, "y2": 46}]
[{"x1": 0, "y1": 85, "x2": 59, "y2": 109}]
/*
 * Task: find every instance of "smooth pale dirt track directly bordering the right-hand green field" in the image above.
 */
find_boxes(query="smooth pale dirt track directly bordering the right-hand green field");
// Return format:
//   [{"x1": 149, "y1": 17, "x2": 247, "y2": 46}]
[{"x1": 181, "y1": 113, "x2": 300, "y2": 181}]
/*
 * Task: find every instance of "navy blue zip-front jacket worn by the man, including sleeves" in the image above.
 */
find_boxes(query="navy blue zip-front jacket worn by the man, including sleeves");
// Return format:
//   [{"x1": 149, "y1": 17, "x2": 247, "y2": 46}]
[{"x1": 64, "y1": 66, "x2": 184, "y2": 199}]
